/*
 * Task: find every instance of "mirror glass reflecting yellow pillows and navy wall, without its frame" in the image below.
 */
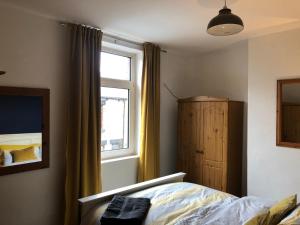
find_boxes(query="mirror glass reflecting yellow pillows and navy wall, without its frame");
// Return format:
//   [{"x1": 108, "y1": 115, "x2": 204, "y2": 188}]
[{"x1": 0, "y1": 95, "x2": 43, "y2": 167}]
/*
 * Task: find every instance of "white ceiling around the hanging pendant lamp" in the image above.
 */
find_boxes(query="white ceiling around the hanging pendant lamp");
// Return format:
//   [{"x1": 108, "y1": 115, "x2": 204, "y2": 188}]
[{"x1": 2, "y1": 0, "x2": 300, "y2": 53}]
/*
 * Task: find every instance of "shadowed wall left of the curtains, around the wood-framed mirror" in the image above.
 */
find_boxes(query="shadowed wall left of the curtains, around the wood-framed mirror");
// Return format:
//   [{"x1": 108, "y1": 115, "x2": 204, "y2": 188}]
[{"x1": 0, "y1": 3, "x2": 68, "y2": 225}]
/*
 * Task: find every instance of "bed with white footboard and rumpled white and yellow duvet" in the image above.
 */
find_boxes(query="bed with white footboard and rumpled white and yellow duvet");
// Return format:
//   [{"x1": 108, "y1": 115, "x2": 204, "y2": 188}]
[{"x1": 79, "y1": 173, "x2": 273, "y2": 225}]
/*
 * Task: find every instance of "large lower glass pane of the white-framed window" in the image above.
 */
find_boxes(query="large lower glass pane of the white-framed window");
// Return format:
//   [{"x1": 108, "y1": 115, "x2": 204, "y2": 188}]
[{"x1": 101, "y1": 87, "x2": 129, "y2": 151}]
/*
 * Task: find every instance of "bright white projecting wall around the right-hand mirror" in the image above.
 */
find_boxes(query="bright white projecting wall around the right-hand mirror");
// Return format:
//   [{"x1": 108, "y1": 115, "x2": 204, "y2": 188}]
[{"x1": 248, "y1": 30, "x2": 300, "y2": 199}]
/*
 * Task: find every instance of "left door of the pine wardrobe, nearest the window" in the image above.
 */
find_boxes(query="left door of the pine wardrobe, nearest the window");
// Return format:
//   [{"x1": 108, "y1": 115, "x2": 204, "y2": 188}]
[{"x1": 177, "y1": 103, "x2": 199, "y2": 183}]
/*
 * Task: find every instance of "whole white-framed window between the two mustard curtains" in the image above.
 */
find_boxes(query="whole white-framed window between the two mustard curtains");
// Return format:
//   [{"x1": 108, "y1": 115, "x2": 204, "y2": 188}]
[{"x1": 100, "y1": 48, "x2": 136, "y2": 159}]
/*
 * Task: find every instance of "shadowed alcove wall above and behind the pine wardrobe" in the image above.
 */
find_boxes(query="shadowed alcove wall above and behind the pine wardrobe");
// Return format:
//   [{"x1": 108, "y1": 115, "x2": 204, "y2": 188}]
[{"x1": 181, "y1": 41, "x2": 248, "y2": 194}]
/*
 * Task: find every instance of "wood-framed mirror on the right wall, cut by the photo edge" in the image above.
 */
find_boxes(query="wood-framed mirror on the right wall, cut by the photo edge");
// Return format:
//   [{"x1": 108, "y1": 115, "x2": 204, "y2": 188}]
[{"x1": 276, "y1": 79, "x2": 300, "y2": 148}]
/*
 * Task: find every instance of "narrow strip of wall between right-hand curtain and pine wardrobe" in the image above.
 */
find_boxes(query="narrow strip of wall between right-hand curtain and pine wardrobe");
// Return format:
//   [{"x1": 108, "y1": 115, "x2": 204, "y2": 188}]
[{"x1": 160, "y1": 51, "x2": 189, "y2": 176}]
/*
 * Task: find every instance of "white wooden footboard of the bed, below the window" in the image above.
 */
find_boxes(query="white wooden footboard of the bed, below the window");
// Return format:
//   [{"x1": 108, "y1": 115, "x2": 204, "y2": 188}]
[{"x1": 78, "y1": 172, "x2": 186, "y2": 217}]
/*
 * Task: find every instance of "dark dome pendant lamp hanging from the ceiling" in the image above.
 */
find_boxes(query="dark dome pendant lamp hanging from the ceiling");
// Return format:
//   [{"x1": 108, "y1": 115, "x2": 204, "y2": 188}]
[{"x1": 207, "y1": 0, "x2": 244, "y2": 36}]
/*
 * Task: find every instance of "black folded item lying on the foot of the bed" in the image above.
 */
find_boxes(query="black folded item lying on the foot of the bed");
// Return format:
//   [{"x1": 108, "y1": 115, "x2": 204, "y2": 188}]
[{"x1": 100, "y1": 195, "x2": 151, "y2": 225}]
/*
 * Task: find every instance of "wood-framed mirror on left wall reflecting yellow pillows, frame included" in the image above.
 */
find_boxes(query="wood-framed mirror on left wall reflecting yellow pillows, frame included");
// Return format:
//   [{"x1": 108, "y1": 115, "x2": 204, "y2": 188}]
[{"x1": 0, "y1": 87, "x2": 50, "y2": 175}]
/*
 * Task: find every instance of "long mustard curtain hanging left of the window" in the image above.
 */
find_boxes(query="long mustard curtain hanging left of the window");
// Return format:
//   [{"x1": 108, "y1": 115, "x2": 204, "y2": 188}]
[{"x1": 64, "y1": 25, "x2": 102, "y2": 225}]
